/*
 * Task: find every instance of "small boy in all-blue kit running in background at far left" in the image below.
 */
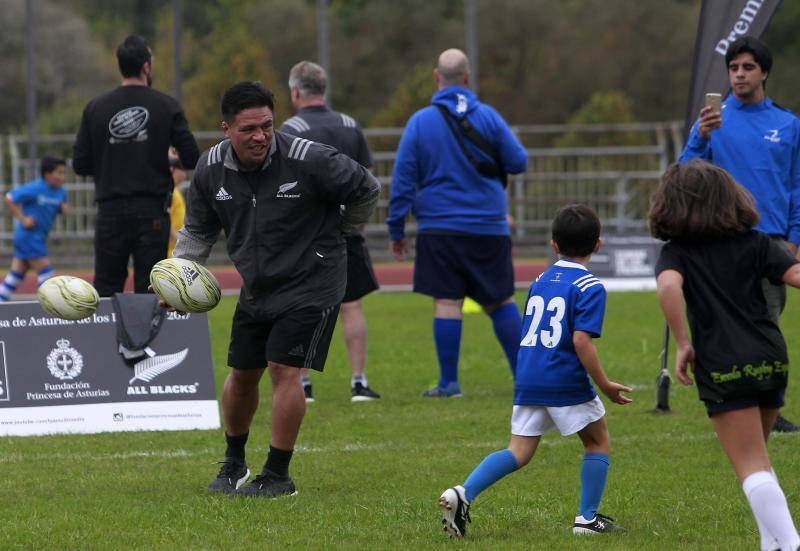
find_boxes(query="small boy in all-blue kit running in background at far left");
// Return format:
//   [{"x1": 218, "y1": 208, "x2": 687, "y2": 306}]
[{"x1": 0, "y1": 157, "x2": 67, "y2": 302}]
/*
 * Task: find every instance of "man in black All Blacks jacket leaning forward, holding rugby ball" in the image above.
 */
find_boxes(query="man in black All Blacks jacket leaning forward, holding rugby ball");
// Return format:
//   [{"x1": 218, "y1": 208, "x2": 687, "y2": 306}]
[{"x1": 174, "y1": 82, "x2": 380, "y2": 497}]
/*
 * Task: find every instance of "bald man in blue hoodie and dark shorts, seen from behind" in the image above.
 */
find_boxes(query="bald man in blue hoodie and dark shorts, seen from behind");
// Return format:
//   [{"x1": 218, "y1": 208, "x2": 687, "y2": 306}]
[{"x1": 387, "y1": 49, "x2": 528, "y2": 397}]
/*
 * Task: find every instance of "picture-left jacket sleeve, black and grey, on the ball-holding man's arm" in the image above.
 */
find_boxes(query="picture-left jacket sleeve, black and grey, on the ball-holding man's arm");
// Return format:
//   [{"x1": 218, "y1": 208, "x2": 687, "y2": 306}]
[{"x1": 172, "y1": 162, "x2": 222, "y2": 264}]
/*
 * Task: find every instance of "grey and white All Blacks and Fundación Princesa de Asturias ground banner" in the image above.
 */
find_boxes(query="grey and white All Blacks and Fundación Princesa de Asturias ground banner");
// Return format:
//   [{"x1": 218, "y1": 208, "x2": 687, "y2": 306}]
[{"x1": 0, "y1": 299, "x2": 220, "y2": 436}]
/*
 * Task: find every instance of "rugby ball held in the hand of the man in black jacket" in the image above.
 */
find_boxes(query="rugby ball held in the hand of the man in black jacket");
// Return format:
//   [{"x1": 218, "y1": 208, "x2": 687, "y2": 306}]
[{"x1": 150, "y1": 258, "x2": 222, "y2": 314}]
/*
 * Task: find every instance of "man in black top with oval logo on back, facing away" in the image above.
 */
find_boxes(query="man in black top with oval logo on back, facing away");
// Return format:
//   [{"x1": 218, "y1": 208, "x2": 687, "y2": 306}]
[{"x1": 72, "y1": 36, "x2": 200, "y2": 297}]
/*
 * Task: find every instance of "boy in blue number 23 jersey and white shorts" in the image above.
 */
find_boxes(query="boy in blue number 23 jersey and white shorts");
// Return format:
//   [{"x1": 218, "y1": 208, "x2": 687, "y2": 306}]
[{"x1": 439, "y1": 205, "x2": 631, "y2": 537}]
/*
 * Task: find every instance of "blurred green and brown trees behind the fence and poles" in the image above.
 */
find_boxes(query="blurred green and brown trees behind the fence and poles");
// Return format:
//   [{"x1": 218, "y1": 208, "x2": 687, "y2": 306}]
[{"x1": 0, "y1": 0, "x2": 800, "y2": 137}]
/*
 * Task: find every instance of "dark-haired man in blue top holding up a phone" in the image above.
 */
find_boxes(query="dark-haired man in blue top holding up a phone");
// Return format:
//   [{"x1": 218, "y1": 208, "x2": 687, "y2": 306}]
[{"x1": 680, "y1": 36, "x2": 800, "y2": 432}]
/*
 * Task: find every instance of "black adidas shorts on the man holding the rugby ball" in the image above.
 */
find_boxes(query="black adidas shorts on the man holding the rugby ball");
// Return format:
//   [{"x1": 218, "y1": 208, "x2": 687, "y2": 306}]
[{"x1": 228, "y1": 304, "x2": 339, "y2": 371}]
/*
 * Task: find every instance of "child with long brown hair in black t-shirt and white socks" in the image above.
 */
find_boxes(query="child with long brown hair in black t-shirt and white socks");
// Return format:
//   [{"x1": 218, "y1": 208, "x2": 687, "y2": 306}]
[{"x1": 650, "y1": 160, "x2": 800, "y2": 551}]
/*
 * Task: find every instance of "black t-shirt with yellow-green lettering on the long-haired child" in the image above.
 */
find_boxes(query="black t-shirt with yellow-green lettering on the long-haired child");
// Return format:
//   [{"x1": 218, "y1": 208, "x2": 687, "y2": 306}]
[{"x1": 656, "y1": 230, "x2": 796, "y2": 401}]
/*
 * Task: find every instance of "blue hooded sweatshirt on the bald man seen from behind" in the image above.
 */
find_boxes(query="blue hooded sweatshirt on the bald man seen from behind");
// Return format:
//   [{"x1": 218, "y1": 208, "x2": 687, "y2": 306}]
[{"x1": 387, "y1": 86, "x2": 528, "y2": 241}]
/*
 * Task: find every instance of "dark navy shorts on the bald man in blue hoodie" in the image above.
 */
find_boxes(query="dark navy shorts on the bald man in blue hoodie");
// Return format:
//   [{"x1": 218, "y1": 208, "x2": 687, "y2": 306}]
[{"x1": 414, "y1": 233, "x2": 514, "y2": 305}]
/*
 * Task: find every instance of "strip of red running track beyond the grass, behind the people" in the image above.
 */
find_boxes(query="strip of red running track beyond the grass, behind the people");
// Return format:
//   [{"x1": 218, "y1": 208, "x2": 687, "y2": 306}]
[{"x1": 17, "y1": 261, "x2": 547, "y2": 295}]
